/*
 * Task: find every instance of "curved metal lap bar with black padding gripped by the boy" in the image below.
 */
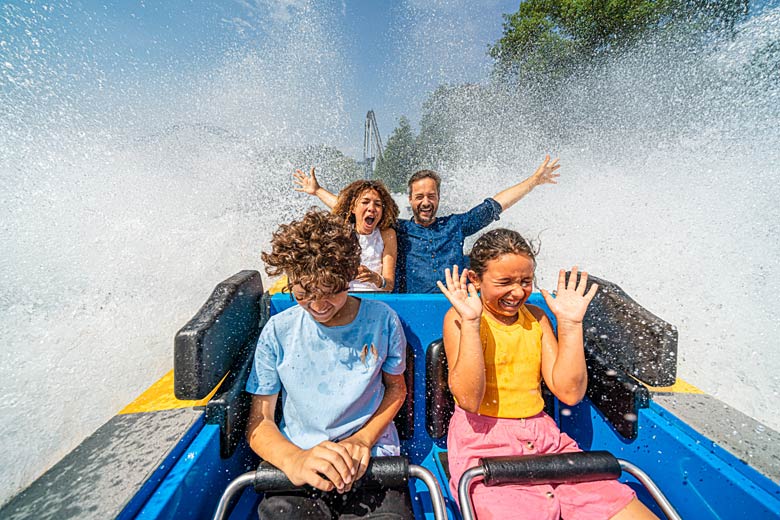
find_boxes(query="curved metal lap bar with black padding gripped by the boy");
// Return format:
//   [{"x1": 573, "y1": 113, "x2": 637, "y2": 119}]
[{"x1": 213, "y1": 457, "x2": 447, "y2": 520}]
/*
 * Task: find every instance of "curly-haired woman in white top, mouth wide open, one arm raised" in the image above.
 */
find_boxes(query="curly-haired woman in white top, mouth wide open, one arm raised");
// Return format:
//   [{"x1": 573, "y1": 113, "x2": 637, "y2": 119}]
[{"x1": 294, "y1": 168, "x2": 398, "y2": 292}]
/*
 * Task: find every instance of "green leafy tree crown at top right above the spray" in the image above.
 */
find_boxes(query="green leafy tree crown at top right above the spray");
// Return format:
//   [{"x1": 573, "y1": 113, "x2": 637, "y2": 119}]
[{"x1": 489, "y1": 0, "x2": 749, "y2": 79}]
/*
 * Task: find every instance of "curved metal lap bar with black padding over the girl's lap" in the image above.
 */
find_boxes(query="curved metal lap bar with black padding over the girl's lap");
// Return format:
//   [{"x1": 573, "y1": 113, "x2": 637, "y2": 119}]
[{"x1": 458, "y1": 451, "x2": 682, "y2": 520}]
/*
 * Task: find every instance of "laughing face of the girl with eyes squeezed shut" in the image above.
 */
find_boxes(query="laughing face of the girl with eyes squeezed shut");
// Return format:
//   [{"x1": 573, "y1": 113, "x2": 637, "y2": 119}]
[{"x1": 469, "y1": 253, "x2": 535, "y2": 325}]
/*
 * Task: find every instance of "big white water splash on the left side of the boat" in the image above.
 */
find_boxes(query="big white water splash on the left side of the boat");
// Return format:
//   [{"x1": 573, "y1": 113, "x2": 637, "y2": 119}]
[{"x1": 0, "y1": 2, "x2": 349, "y2": 502}]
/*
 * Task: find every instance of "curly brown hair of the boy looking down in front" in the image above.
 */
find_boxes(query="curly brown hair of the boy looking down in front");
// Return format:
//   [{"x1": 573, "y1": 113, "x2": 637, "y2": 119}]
[{"x1": 261, "y1": 208, "x2": 360, "y2": 299}]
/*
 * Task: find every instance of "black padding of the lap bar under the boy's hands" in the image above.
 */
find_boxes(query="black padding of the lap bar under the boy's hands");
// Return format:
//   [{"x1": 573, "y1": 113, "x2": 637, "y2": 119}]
[{"x1": 254, "y1": 457, "x2": 409, "y2": 492}]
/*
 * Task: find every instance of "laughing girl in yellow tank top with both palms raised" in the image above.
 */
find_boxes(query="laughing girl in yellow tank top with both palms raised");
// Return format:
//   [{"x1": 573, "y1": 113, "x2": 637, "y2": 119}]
[{"x1": 438, "y1": 229, "x2": 656, "y2": 520}]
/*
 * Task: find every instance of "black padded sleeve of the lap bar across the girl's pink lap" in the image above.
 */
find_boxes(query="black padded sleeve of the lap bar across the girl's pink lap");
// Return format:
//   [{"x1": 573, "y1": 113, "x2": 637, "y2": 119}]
[{"x1": 480, "y1": 451, "x2": 622, "y2": 486}]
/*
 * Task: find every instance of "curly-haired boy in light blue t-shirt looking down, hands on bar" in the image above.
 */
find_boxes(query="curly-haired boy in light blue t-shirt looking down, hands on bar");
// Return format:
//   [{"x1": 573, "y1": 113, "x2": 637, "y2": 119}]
[{"x1": 246, "y1": 210, "x2": 413, "y2": 519}]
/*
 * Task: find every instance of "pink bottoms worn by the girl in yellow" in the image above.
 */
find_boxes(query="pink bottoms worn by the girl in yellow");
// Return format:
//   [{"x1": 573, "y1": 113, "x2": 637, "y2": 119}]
[{"x1": 447, "y1": 406, "x2": 636, "y2": 520}]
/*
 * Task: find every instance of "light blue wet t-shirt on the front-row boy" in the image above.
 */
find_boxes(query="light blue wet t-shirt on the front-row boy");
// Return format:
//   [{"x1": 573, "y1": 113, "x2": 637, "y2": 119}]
[{"x1": 246, "y1": 299, "x2": 406, "y2": 456}]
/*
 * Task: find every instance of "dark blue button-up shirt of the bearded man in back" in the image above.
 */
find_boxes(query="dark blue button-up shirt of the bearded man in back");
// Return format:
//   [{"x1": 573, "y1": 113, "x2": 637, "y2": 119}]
[{"x1": 395, "y1": 199, "x2": 501, "y2": 293}]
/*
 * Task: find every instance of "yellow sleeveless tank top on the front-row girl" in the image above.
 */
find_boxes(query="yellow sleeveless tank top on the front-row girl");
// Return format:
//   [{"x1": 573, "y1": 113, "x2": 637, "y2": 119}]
[{"x1": 479, "y1": 305, "x2": 544, "y2": 419}]
